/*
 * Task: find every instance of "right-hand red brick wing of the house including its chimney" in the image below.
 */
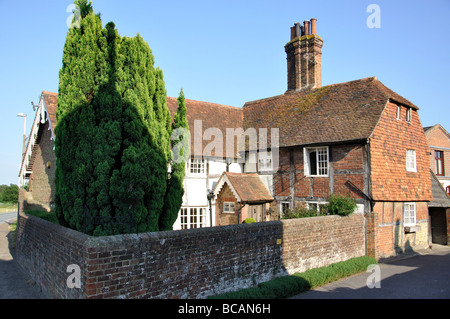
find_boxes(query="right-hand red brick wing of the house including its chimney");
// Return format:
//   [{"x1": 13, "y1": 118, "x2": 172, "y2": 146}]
[{"x1": 243, "y1": 19, "x2": 432, "y2": 258}]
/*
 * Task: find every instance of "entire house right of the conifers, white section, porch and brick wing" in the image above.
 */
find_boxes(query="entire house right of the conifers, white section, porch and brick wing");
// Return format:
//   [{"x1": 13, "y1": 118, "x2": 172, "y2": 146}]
[{"x1": 20, "y1": 19, "x2": 433, "y2": 258}]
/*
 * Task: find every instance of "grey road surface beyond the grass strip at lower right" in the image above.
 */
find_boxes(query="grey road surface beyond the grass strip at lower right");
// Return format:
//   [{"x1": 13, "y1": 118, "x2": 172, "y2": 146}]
[{"x1": 293, "y1": 244, "x2": 450, "y2": 299}]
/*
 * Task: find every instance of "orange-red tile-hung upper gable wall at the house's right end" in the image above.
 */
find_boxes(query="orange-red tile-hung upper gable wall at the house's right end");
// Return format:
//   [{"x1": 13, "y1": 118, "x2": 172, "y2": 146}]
[{"x1": 370, "y1": 103, "x2": 432, "y2": 202}]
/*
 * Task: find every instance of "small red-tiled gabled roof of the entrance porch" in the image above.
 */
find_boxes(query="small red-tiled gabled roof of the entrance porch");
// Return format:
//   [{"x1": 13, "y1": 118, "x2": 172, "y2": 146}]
[{"x1": 215, "y1": 172, "x2": 274, "y2": 203}]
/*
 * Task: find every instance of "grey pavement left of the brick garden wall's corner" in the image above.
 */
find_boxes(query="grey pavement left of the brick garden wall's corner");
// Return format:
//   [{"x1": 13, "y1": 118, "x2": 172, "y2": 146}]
[{"x1": 0, "y1": 212, "x2": 49, "y2": 299}]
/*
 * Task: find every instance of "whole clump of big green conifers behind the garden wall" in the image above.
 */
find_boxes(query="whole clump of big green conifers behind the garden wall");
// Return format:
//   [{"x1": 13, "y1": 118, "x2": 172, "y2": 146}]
[{"x1": 55, "y1": 0, "x2": 184, "y2": 235}]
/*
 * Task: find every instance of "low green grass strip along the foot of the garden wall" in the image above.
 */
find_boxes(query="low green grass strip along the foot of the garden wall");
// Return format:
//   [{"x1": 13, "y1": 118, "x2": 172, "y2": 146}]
[{"x1": 208, "y1": 256, "x2": 377, "y2": 299}]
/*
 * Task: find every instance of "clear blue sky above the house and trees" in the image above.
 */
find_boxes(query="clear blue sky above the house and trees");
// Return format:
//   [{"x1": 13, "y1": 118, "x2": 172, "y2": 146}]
[{"x1": 0, "y1": 0, "x2": 450, "y2": 184}]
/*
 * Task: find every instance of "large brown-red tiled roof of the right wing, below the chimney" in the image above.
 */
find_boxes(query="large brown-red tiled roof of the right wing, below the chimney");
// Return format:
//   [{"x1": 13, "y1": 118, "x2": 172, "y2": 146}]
[{"x1": 243, "y1": 77, "x2": 418, "y2": 147}]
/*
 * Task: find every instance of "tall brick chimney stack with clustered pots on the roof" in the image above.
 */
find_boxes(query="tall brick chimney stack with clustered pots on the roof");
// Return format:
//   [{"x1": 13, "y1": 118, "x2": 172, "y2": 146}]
[{"x1": 284, "y1": 19, "x2": 323, "y2": 91}]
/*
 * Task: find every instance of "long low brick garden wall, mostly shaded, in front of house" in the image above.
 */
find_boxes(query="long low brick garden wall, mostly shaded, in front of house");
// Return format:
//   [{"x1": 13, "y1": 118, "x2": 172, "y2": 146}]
[{"x1": 15, "y1": 206, "x2": 365, "y2": 298}]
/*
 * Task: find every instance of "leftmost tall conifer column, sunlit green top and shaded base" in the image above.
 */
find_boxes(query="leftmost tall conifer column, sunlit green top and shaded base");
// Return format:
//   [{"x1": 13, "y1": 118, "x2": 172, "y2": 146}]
[{"x1": 55, "y1": 0, "x2": 107, "y2": 229}]
